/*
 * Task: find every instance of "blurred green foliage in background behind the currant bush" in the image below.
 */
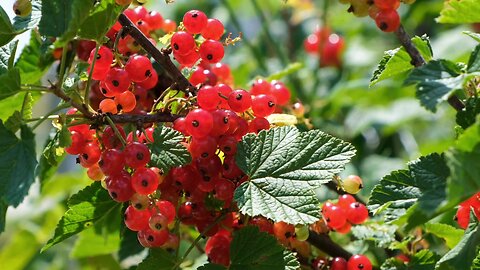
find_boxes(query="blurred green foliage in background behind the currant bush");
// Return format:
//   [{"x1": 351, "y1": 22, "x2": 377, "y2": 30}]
[{"x1": 0, "y1": 0, "x2": 475, "y2": 270}]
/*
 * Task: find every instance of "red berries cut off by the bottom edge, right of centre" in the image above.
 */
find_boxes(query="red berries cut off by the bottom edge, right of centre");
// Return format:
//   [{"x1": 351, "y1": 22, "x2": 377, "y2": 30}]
[{"x1": 313, "y1": 255, "x2": 372, "y2": 270}]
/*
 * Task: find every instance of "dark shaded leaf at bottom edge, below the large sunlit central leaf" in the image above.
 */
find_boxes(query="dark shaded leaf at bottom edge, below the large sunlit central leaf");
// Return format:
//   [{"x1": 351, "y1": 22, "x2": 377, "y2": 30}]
[{"x1": 229, "y1": 226, "x2": 300, "y2": 270}]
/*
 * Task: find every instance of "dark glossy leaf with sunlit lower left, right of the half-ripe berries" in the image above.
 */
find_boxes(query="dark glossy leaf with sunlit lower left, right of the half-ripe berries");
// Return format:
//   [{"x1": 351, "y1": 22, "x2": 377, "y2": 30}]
[{"x1": 368, "y1": 154, "x2": 450, "y2": 228}]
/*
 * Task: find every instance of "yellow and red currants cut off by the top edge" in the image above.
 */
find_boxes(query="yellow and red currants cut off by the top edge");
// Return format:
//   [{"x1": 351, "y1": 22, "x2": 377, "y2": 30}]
[{"x1": 339, "y1": 0, "x2": 415, "y2": 32}]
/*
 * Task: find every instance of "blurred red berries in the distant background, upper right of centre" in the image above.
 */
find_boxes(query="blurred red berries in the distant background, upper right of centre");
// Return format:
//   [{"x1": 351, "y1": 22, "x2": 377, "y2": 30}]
[{"x1": 303, "y1": 27, "x2": 345, "y2": 67}]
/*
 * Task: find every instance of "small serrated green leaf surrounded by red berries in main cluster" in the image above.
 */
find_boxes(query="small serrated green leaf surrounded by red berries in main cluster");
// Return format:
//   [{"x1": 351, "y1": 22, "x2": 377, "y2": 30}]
[{"x1": 148, "y1": 126, "x2": 192, "y2": 173}]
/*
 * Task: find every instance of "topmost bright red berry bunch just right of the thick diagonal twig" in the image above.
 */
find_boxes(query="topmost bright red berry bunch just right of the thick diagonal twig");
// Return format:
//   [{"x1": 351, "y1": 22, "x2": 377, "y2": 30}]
[{"x1": 170, "y1": 10, "x2": 225, "y2": 67}]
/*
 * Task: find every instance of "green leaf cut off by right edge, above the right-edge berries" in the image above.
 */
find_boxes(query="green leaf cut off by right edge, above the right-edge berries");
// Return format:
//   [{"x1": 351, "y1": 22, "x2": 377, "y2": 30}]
[{"x1": 445, "y1": 122, "x2": 480, "y2": 205}]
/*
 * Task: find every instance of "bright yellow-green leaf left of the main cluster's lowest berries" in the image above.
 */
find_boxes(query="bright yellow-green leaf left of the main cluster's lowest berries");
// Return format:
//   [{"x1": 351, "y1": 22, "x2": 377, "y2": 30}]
[{"x1": 71, "y1": 202, "x2": 123, "y2": 259}]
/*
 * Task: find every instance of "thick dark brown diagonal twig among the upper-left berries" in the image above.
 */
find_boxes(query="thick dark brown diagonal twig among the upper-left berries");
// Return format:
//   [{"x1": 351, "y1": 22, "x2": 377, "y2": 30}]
[{"x1": 118, "y1": 14, "x2": 197, "y2": 94}]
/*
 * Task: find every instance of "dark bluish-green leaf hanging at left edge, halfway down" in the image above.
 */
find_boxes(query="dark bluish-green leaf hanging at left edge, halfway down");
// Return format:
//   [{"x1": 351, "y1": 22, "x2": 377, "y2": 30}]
[{"x1": 0, "y1": 124, "x2": 37, "y2": 231}]
